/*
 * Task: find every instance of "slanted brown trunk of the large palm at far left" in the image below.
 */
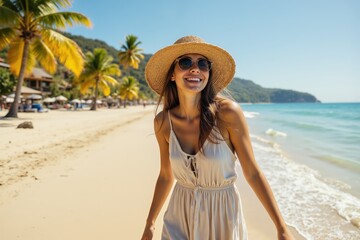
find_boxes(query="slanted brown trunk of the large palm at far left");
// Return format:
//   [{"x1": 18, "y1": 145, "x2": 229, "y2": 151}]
[{"x1": 5, "y1": 40, "x2": 30, "y2": 118}]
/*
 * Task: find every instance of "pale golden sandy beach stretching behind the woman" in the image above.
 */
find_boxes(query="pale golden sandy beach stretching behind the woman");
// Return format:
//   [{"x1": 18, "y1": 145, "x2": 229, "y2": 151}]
[{"x1": 0, "y1": 106, "x2": 302, "y2": 240}]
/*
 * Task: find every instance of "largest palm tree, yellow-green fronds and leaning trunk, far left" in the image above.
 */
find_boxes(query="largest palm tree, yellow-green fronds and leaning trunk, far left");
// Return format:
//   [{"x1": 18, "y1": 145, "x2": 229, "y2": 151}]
[{"x1": 0, "y1": 0, "x2": 91, "y2": 117}]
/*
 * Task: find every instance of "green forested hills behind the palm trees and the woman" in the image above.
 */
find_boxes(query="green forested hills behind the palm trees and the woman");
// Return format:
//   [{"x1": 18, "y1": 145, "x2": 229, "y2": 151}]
[{"x1": 0, "y1": 33, "x2": 319, "y2": 103}]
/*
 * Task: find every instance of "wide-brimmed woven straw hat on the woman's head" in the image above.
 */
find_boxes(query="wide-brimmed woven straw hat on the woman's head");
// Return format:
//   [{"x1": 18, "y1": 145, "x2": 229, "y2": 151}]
[{"x1": 145, "y1": 36, "x2": 235, "y2": 95}]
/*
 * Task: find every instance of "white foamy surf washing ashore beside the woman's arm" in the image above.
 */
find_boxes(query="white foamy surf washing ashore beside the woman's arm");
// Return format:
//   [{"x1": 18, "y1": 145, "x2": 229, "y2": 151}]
[{"x1": 252, "y1": 136, "x2": 360, "y2": 240}]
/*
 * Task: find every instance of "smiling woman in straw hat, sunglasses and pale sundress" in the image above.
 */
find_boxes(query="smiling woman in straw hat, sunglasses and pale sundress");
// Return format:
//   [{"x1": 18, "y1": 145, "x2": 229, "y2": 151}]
[{"x1": 142, "y1": 36, "x2": 293, "y2": 240}]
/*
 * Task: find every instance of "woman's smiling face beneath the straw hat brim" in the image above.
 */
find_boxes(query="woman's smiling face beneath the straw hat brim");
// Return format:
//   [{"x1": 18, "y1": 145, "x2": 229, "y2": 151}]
[{"x1": 171, "y1": 54, "x2": 209, "y2": 93}]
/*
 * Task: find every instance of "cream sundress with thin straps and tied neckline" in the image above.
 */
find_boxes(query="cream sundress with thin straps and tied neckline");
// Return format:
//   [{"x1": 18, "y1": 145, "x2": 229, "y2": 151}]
[{"x1": 161, "y1": 111, "x2": 247, "y2": 240}]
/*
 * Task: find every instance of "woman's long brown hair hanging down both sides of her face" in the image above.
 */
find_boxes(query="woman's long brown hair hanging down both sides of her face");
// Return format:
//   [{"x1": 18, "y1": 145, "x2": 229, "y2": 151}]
[{"x1": 155, "y1": 63, "x2": 225, "y2": 151}]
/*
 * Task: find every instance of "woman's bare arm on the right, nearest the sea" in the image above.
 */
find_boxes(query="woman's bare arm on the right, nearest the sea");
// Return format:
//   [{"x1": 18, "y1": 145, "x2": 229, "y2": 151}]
[{"x1": 221, "y1": 100, "x2": 293, "y2": 239}]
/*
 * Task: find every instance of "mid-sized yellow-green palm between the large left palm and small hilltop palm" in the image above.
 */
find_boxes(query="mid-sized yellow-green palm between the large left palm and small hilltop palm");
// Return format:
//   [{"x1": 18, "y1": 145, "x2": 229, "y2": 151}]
[{"x1": 79, "y1": 48, "x2": 121, "y2": 110}]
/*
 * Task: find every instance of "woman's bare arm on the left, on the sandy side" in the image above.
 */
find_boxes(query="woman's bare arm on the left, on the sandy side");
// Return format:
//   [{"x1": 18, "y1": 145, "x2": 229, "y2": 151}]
[{"x1": 141, "y1": 112, "x2": 174, "y2": 240}]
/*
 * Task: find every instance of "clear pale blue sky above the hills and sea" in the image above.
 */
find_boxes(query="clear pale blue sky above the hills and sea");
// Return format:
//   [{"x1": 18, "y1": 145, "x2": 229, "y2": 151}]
[{"x1": 69, "y1": 0, "x2": 360, "y2": 102}]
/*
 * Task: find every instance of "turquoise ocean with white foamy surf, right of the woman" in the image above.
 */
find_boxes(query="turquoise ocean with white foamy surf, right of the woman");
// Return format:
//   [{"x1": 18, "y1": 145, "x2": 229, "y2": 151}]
[{"x1": 240, "y1": 103, "x2": 360, "y2": 240}]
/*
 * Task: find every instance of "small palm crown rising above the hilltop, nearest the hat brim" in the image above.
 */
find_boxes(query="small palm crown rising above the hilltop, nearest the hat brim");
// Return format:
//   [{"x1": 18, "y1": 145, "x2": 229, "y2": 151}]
[{"x1": 118, "y1": 35, "x2": 144, "y2": 69}]
